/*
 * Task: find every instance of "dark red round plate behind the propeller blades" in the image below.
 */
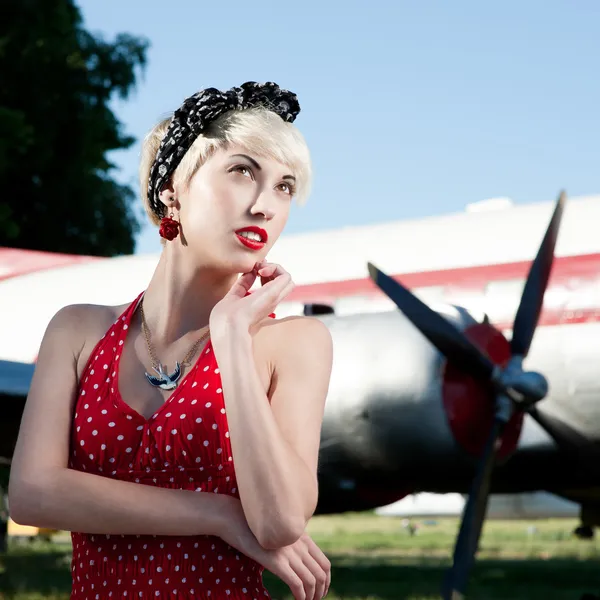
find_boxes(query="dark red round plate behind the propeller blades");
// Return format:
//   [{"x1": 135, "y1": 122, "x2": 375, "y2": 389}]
[{"x1": 442, "y1": 323, "x2": 524, "y2": 459}]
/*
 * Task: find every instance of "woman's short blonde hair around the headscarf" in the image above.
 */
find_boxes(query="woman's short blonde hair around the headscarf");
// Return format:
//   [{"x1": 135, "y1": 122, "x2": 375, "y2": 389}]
[{"x1": 139, "y1": 107, "x2": 312, "y2": 225}]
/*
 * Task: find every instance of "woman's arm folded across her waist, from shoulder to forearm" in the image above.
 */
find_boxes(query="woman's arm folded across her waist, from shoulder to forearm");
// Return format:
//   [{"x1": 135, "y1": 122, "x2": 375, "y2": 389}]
[{"x1": 9, "y1": 305, "x2": 237, "y2": 537}]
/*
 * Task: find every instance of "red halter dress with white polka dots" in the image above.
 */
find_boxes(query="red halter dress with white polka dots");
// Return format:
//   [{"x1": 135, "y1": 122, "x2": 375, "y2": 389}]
[{"x1": 69, "y1": 294, "x2": 270, "y2": 600}]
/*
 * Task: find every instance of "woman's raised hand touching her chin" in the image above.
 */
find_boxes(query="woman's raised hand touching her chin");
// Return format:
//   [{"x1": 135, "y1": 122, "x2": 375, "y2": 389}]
[{"x1": 209, "y1": 261, "x2": 295, "y2": 339}]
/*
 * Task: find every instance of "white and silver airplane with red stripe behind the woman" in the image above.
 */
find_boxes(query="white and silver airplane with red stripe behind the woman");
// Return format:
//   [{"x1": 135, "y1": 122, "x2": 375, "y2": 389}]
[{"x1": 0, "y1": 195, "x2": 600, "y2": 597}]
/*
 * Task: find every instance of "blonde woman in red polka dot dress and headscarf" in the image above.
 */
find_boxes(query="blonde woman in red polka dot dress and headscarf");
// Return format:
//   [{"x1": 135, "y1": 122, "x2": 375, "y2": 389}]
[{"x1": 9, "y1": 82, "x2": 332, "y2": 600}]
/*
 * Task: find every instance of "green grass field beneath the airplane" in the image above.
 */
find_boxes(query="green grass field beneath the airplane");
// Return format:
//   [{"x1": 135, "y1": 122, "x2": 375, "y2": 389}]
[{"x1": 0, "y1": 514, "x2": 600, "y2": 600}]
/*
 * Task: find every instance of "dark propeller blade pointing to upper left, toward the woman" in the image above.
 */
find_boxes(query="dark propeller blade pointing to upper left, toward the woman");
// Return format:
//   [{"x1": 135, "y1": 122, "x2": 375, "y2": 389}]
[{"x1": 367, "y1": 262, "x2": 495, "y2": 379}]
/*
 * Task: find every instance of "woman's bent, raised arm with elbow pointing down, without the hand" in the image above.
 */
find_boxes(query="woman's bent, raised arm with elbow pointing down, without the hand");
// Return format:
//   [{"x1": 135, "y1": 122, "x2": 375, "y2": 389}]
[{"x1": 213, "y1": 317, "x2": 333, "y2": 548}]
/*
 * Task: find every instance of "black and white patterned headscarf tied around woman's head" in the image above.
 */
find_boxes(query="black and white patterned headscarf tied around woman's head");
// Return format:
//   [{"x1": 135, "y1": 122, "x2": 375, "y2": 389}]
[{"x1": 148, "y1": 81, "x2": 300, "y2": 217}]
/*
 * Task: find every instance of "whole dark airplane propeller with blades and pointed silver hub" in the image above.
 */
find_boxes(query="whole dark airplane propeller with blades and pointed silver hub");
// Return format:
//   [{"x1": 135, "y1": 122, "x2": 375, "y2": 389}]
[{"x1": 368, "y1": 192, "x2": 566, "y2": 600}]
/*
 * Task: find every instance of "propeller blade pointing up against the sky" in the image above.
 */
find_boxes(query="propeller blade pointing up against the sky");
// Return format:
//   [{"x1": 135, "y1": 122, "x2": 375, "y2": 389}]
[{"x1": 510, "y1": 191, "x2": 566, "y2": 356}]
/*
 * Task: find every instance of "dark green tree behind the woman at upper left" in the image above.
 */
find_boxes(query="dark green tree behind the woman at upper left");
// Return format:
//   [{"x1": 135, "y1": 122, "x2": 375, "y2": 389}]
[{"x1": 0, "y1": 0, "x2": 148, "y2": 256}]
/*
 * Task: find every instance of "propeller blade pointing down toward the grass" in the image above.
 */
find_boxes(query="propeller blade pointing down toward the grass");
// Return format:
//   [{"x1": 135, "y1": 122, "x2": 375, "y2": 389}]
[{"x1": 442, "y1": 418, "x2": 505, "y2": 600}]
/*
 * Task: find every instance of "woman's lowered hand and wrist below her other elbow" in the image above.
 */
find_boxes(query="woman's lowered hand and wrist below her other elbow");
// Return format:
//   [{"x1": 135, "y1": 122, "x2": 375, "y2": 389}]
[{"x1": 219, "y1": 498, "x2": 331, "y2": 600}]
